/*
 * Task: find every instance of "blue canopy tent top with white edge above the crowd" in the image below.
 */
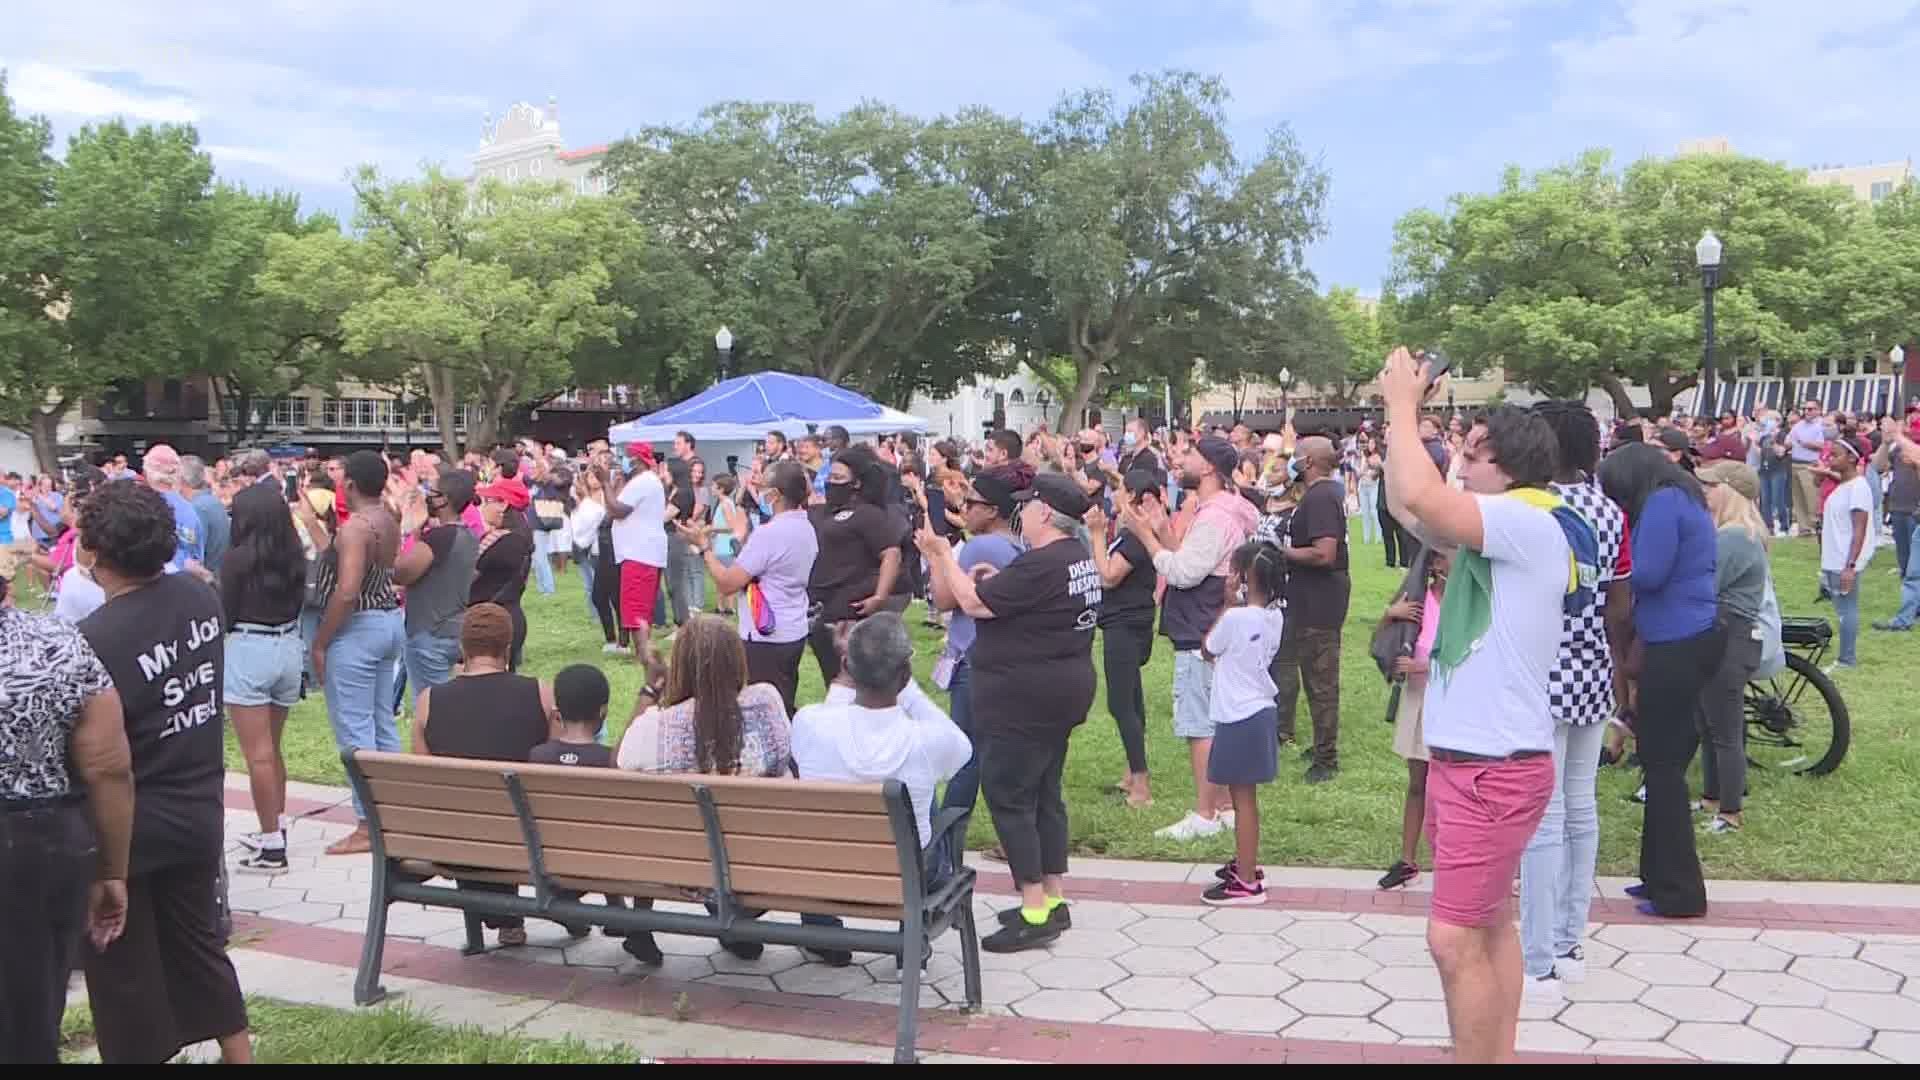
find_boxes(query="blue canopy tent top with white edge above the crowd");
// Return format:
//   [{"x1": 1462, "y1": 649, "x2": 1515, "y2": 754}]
[{"x1": 607, "y1": 371, "x2": 927, "y2": 446}]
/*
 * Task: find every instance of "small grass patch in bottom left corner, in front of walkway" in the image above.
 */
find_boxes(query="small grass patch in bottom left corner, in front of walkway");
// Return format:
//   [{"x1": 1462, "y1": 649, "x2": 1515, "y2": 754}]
[{"x1": 60, "y1": 997, "x2": 641, "y2": 1065}]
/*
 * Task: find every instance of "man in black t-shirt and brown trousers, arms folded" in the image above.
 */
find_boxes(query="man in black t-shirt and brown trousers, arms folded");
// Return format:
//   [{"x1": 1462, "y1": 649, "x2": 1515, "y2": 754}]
[{"x1": 1273, "y1": 434, "x2": 1354, "y2": 784}]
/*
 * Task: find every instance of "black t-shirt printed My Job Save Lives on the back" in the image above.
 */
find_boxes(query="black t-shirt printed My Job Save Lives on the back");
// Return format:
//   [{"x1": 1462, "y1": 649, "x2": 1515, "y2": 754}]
[{"x1": 81, "y1": 575, "x2": 227, "y2": 874}]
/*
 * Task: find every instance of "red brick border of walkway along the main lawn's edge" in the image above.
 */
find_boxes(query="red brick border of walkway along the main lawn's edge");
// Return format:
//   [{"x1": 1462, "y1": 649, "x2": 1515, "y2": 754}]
[{"x1": 240, "y1": 788, "x2": 1920, "y2": 934}]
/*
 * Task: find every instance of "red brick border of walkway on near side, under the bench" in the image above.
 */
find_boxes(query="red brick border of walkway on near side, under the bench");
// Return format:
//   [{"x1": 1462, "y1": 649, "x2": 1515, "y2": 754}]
[{"x1": 234, "y1": 915, "x2": 1681, "y2": 1065}]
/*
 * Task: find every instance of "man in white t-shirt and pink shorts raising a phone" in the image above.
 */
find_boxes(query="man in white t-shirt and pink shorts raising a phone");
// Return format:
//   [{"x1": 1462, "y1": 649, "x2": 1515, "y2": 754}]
[{"x1": 1380, "y1": 348, "x2": 1592, "y2": 1063}]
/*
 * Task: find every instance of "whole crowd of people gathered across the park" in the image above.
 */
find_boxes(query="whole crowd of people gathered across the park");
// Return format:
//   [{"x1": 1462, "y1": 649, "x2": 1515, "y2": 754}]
[{"x1": 0, "y1": 376, "x2": 1920, "y2": 1061}]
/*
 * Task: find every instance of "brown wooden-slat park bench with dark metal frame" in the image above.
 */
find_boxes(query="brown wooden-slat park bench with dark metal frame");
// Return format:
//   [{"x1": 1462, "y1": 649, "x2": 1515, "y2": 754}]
[{"x1": 342, "y1": 751, "x2": 981, "y2": 1063}]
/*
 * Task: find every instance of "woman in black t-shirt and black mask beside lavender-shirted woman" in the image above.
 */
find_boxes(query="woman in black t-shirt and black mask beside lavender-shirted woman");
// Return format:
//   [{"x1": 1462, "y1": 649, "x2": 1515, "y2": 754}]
[{"x1": 806, "y1": 446, "x2": 906, "y2": 682}]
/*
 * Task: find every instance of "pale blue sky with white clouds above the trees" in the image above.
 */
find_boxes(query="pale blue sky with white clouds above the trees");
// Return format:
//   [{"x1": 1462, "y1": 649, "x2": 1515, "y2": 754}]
[{"x1": 0, "y1": 0, "x2": 1920, "y2": 292}]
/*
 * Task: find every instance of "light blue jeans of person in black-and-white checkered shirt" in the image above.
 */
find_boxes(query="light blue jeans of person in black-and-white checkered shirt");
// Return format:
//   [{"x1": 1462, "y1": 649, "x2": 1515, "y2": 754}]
[{"x1": 1521, "y1": 723, "x2": 1607, "y2": 978}]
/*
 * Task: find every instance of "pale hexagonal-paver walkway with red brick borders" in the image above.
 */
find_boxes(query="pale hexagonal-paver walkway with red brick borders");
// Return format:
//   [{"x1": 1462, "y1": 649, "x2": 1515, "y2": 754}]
[{"x1": 228, "y1": 776, "x2": 1920, "y2": 1063}]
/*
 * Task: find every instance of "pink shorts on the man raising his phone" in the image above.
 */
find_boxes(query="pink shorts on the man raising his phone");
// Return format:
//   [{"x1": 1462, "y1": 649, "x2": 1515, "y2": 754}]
[{"x1": 1427, "y1": 753, "x2": 1553, "y2": 926}]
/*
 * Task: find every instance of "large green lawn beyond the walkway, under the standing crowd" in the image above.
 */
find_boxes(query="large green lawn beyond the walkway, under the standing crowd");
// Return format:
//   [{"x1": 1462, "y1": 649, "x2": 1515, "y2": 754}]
[{"x1": 210, "y1": 523, "x2": 1920, "y2": 882}]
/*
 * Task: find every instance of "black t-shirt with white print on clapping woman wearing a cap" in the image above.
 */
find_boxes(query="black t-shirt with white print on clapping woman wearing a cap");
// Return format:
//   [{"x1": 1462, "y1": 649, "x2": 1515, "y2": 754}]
[{"x1": 970, "y1": 536, "x2": 1100, "y2": 740}]
